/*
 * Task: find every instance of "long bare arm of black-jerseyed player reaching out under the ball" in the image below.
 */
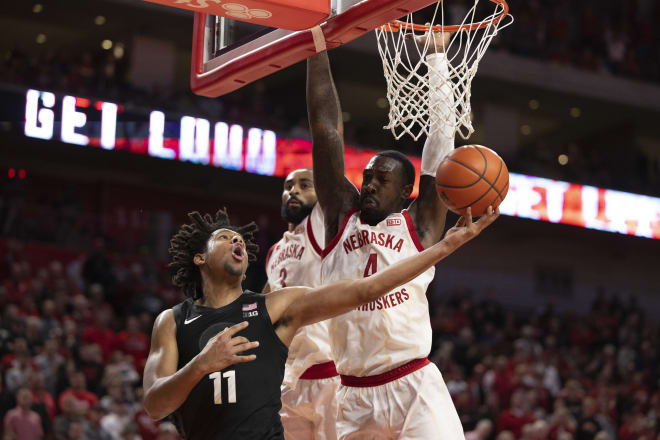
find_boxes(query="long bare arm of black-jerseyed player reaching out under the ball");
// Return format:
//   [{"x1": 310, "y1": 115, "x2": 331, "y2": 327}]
[{"x1": 266, "y1": 208, "x2": 499, "y2": 344}]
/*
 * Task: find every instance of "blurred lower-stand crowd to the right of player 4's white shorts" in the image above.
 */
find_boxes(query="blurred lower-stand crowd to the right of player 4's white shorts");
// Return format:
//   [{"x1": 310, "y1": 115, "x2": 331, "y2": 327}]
[{"x1": 432, "y1": 292, "x2": 660, "y2": 440}]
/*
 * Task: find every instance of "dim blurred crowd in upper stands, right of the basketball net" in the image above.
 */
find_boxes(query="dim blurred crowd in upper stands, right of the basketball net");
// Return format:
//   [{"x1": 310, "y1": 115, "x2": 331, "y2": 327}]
[{"x1": 501, "y1": 0, "x2": 660, "y2": 82}]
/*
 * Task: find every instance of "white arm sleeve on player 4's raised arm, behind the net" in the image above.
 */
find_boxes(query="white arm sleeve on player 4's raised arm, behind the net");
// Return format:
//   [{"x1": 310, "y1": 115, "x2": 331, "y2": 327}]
[{"x1": 422, "y1": 53, "x2": 456, "y2": 176}]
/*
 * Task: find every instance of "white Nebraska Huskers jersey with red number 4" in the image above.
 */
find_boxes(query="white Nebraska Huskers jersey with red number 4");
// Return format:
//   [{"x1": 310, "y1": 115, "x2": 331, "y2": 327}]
[{"x1": 321, "y1": 208, "x2": 435, "y2": 376}]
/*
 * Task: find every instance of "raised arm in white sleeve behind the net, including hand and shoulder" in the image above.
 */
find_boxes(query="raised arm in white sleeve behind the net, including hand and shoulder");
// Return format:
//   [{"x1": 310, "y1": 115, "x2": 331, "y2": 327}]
[{"x1": 408, "y1": 33, "x2": 456, "y2": 248}]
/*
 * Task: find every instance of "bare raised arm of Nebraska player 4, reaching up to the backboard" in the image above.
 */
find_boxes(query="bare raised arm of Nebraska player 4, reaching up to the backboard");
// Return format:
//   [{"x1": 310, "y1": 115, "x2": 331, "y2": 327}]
[{"x1": 307, "y1": 52, "x2": 358, "y2": 239}]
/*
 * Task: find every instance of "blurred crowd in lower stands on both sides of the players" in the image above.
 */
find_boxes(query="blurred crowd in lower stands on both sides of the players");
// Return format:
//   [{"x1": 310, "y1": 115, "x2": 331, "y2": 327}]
[{"x1": 0, "y1": 240, "x2": 660, "y2": 440}]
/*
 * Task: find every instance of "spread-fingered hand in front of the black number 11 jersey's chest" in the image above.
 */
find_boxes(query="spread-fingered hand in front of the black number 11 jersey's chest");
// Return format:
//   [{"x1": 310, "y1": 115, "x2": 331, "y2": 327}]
[{"x1": 197, "y1": 321, "x2": 259, "y2": 373}]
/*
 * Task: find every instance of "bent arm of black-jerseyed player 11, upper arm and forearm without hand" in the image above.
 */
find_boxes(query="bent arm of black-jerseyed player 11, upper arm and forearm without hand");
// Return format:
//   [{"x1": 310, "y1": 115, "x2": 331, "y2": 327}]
[{"x1": 143, "y1": 309, "x2": 203, "y2": 420}]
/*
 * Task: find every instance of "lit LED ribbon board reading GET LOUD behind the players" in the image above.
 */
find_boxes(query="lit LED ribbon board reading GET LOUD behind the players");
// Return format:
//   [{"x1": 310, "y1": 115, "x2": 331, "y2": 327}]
[{"x1": 24, "y1": 90, "x2": 660, "y2": 239}]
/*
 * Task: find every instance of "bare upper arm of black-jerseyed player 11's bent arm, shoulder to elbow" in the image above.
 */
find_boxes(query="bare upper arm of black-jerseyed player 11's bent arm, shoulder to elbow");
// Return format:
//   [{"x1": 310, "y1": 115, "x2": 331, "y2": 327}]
[{"x1": 143, "y1": 309, "x2": 179, "y2": 392}]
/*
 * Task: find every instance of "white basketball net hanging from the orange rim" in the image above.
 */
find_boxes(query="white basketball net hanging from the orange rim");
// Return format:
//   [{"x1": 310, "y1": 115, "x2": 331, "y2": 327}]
[{"x1": 376, "y1": 0, "x2": 513, "y2": 140}]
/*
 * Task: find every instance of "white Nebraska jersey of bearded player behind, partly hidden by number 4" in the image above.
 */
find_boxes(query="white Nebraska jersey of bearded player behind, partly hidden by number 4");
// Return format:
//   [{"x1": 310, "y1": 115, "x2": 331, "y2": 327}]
[{"x1": 266, "y1": 203, "x2": 331, "y2": 388}]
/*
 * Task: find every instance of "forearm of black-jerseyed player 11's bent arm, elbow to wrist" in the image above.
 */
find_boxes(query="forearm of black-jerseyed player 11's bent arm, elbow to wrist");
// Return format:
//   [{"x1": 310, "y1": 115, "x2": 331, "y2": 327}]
[{"x1": 143, "y1": 358, "x2": 206, "y2": 420}]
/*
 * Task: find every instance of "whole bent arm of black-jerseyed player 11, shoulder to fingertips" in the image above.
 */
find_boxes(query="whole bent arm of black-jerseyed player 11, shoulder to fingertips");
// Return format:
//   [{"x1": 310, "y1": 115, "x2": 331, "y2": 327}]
[{"x1": 143, "y1": 309, "x2": 259, "y2": 420}]
